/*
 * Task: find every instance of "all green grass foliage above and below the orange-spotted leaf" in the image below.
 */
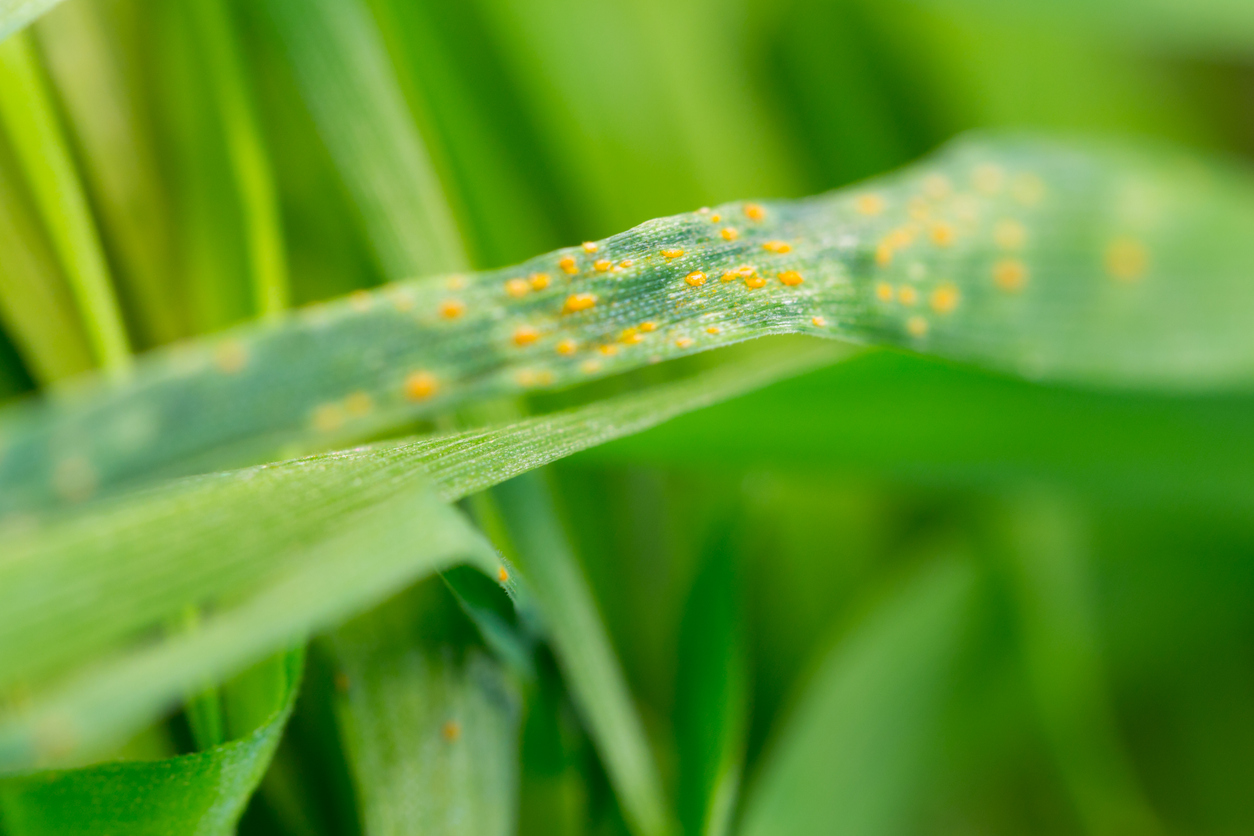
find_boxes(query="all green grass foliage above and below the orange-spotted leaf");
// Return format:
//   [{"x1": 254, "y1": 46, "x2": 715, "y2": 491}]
[{"x1": 0, "y1": 0, "x2": 1254, "y2": 836}]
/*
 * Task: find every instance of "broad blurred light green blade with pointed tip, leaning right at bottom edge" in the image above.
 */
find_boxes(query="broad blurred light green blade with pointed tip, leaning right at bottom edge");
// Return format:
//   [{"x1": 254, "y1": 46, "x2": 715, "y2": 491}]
[{"x1": 740, "y1": 560, "x2": 976, "y2": 836}]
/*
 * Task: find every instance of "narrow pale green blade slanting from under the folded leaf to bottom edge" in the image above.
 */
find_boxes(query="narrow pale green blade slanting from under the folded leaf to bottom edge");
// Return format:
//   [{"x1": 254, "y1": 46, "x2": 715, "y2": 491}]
[{"x1": 494, "y1": 476, "x2": 672, "y2": 836}]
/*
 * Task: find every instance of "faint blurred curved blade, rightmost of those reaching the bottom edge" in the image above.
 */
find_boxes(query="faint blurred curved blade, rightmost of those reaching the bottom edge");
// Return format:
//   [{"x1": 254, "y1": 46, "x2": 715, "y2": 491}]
[{"x1": 998, "y1": 494, "x2": 1162, "y2": 836}]
